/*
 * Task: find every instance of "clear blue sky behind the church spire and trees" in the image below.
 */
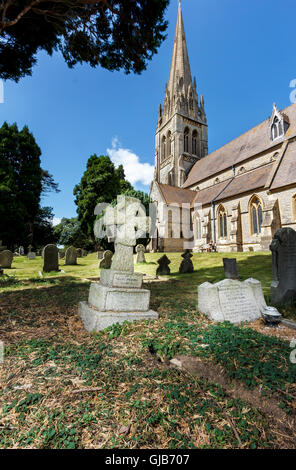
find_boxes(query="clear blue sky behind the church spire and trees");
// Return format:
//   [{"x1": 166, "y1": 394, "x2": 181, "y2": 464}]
[{"x1": 0, "y1": 0, "x2": 296, "y2": 223}]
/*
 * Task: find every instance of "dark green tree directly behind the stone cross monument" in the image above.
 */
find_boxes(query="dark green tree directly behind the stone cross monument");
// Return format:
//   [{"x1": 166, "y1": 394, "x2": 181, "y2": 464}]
[{"x1": 74, "y1": 154, "x2": 130, "y2": 250}]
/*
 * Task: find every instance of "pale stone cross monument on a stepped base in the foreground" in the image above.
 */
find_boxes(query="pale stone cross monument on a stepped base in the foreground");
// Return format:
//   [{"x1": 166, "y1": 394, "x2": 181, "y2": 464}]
[{"x1": 78, "y1": 196, "x2": 158, "y2": 331}]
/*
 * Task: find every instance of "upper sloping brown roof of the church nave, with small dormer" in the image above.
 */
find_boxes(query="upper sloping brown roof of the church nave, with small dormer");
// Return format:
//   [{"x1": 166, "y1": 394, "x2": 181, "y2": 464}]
[{"x1": 183, "y1": 103, "x2": 296, "y2": 188}]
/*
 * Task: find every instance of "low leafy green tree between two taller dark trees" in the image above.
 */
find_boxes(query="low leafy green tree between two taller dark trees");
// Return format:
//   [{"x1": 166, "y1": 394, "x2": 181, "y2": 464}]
[{"x1": 53, "y1": 217, "x2": 94, "y2": 250}]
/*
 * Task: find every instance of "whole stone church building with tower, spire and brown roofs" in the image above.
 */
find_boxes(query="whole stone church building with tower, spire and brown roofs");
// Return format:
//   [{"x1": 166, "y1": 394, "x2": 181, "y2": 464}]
[{"x1": 150, "y1": 3, "x2": 296, "y2": 252}]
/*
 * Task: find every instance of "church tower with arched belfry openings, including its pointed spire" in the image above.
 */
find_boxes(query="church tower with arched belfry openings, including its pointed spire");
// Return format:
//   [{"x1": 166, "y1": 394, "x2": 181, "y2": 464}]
[{"x1": 154, "y1": 0, "x2": 208, "y2": 187}]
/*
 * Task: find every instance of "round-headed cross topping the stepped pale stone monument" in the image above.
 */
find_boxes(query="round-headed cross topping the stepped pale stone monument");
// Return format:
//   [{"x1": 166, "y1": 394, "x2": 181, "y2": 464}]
[{"x1": 104, "y1": 196, "x2": 150, "y2": 273}]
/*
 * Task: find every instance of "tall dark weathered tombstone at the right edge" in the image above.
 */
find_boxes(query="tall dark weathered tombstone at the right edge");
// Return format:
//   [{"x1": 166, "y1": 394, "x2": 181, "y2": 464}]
[{"x1": 270, "y1": 227, "x2": 296, "y2": 305}]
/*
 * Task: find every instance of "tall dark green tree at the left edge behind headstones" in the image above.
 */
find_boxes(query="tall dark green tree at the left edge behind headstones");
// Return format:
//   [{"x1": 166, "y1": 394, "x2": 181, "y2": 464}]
[{"x1": 0, "y1": 122, "x2": 58, "y2": 248}]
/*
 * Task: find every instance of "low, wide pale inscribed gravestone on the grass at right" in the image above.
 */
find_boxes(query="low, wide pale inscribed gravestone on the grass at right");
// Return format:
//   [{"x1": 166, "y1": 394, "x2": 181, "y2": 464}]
[{"x1": 198, "y1": 278, "x2": 266, "y2": 323}]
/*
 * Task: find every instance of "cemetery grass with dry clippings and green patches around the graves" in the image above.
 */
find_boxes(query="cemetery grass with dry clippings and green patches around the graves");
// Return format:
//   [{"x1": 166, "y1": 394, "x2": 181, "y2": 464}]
[{"x1": 0, "y1": 253, "x2": 296, "y2": 449}]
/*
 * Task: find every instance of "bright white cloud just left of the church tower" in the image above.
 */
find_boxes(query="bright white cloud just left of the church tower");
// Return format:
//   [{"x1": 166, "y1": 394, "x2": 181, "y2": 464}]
[{"x1": 107, "y1": 137, "x2": 154, "y2": 186}]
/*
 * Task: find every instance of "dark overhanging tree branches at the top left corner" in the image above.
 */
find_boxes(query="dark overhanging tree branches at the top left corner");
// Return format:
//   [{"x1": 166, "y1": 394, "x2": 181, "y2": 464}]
[{"x1": 0, "y1": 0, "x2": 169, "y2": 81}]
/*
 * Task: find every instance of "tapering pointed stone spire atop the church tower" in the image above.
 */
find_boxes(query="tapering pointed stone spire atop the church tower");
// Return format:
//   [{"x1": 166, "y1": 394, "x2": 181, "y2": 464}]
[{"x1": 168, "y1": 0, "x2": 192, "y2": 98}]
